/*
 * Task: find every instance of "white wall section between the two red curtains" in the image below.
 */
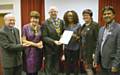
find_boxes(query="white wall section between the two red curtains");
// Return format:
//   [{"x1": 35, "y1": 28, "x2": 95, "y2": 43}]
[{"x1": 45, "y1": 0, "x2": 98, "y2": 24}]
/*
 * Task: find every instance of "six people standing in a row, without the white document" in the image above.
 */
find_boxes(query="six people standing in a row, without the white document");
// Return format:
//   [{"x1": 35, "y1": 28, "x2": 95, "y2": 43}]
[{"x1": 0, "y1": 6, "x2": 120, "y2": 75}]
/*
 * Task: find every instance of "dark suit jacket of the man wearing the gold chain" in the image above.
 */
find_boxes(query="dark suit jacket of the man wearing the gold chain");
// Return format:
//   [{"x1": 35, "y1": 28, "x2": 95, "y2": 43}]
[{"x1": 42, "y1": 18, "x2": 64, "y2": 54}]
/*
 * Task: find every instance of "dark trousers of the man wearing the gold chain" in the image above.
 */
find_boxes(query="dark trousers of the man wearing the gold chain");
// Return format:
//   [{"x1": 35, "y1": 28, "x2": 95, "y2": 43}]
[{"x1": 45, "y1": 54, "x2": 59, "y2": 75}]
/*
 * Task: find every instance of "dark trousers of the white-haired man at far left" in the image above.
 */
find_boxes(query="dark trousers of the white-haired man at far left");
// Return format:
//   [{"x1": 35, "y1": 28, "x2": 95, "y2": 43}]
[{"x1": 4, "y1": 66, "x2": 22, "y2": 75}]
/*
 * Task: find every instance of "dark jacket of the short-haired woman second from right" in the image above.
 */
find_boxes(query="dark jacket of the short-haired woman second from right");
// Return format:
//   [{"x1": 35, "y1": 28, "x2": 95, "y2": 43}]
[{"x1": 81, "y1": 21, "x2": 99, "y2": 53}]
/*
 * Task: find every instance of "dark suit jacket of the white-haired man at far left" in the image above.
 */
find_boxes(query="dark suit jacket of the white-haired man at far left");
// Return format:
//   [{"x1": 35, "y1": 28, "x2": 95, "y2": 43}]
[{"x1": 0, "y1": 26, "x2": 23, "y2": 68}]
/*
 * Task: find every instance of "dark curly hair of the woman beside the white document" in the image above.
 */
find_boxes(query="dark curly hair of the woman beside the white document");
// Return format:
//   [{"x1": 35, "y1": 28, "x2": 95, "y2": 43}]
[{"x1": 63, "y1": 10, "x2": 79, "y2": 24}]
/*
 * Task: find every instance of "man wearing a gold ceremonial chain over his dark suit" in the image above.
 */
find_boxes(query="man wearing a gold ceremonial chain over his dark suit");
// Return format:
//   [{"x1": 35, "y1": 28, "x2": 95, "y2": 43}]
[{"x1": 43, "y1": 6, "x2": 63, "y2": 75}]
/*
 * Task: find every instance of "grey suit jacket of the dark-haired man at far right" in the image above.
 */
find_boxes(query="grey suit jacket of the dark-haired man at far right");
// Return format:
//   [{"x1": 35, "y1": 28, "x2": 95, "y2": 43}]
[{"x1": 96, "y1": 23, "x2": 120, "y2": 69}]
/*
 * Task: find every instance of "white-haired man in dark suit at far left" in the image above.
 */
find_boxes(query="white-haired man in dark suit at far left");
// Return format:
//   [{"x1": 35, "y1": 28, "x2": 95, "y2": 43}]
[{"x1": 0, "y1": 14, "x2": 27, "y2": 75}]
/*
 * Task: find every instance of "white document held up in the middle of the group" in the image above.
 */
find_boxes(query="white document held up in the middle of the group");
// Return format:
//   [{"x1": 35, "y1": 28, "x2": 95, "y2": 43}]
[{"x1": 59, "y1": 30, "x2": 73, "y2": 44}]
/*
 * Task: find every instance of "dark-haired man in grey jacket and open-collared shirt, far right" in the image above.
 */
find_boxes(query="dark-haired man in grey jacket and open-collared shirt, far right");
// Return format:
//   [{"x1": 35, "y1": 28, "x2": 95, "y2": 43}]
[{"x1": 95, "y1": 6, "x2": 120, "y2": 75}]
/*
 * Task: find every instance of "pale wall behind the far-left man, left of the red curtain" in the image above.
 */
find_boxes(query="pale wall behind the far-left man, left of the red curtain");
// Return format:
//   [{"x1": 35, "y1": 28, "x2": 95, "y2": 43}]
[{"x1": 0, "y1": 0, "x2": 21, "y2": 30}]
